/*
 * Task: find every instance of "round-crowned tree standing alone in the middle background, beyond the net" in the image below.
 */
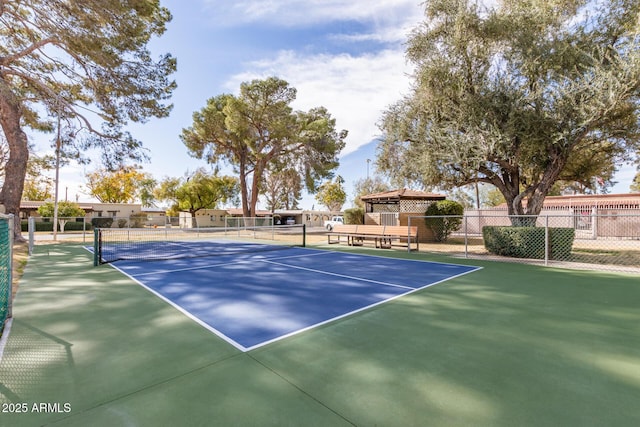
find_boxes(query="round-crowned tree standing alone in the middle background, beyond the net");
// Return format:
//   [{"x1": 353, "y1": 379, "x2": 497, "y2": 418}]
[{"x1": 181, "y1": 77, "x2": 347, "y2": 217}]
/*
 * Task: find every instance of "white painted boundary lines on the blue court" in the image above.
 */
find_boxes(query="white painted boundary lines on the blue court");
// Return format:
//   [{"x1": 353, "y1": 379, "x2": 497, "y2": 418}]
[{"x1": 102, "y1": 248, "x2": 483, "y2": 352}]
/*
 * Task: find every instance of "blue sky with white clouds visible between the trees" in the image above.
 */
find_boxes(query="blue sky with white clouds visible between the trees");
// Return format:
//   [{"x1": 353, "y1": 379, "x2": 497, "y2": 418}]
[{"x1": 37, "y1": 0, "x2": 634, "y2": 208}]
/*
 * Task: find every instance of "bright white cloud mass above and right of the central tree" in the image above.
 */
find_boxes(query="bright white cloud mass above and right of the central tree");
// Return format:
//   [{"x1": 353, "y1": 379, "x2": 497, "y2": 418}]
[{"x1": 227, "y1": 50, "x2": 409, "y2": 154}]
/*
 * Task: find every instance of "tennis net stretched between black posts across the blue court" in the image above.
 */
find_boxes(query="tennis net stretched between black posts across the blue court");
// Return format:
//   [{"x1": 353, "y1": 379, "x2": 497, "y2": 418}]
[{"x1": 93, "y1": 225, "x2": 306, "y2": 265}]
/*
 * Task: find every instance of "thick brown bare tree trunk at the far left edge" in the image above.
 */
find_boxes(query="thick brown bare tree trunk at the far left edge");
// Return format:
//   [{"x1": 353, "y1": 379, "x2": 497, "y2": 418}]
[{"x1": 0, "y1": 88, "x2": 29, "y2": 242}]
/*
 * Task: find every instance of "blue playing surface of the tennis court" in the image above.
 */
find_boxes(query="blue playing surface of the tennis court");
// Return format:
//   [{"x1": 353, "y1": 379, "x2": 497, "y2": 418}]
[{"x1": 113, "y1": 248, "x2": 478, "y2": 351}]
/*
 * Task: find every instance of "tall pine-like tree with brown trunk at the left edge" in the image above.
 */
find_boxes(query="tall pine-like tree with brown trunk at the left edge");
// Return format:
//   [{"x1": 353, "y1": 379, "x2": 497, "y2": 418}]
[{"x1": 0, "y1": 0, "x2": 175, "y2": 238}]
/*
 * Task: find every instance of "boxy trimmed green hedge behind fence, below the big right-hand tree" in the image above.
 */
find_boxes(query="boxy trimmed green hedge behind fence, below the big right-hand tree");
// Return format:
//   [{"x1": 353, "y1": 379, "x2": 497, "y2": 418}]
[{"x1": 482, "y1": 226, "x2": 575, "y2": 261}]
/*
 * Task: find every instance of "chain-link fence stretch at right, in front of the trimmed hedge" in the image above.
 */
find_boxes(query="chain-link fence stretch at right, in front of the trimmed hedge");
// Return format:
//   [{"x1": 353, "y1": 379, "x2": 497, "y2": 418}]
[{"x1": 408, "y1": 214, "x2": 640, "y2": 273}]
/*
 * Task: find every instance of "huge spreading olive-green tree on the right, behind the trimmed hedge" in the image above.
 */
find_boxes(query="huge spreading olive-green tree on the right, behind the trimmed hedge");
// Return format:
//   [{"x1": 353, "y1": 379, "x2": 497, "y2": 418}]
[{"x1": 378, "y1": 0, "x2": 640, "y2": 221}]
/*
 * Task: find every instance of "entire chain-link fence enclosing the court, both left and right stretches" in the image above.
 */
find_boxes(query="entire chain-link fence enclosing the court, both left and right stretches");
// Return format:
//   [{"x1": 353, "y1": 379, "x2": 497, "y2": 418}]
[{"x1": 22, "y1": 212, "x2": 640, "y2": 272}]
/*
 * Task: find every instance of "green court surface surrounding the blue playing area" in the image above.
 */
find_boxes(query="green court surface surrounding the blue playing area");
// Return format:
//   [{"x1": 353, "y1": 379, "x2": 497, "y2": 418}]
[{"x1": 0, "y1": 245, "x2": 640, "y2": 426}]
